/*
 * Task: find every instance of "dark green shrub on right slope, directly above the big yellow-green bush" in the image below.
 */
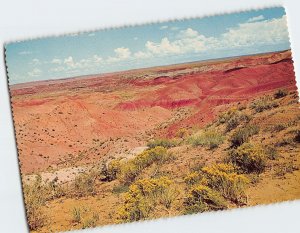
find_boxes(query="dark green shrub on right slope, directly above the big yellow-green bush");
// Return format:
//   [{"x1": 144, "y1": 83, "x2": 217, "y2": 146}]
[{"x1": 230, "y1": 125, "x2": 259, "y2": 147}]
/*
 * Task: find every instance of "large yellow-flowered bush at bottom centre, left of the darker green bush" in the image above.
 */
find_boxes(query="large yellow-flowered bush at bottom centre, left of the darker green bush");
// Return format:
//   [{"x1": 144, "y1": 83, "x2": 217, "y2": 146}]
[{"x1": 117, "y1": 177, "x2": 175, "y2": 222}]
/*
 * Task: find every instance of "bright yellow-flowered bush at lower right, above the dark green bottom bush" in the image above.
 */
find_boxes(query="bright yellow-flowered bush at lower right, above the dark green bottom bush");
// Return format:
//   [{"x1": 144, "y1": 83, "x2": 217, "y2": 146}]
[{"x1": 202, "y1": 163, "x2": 249, "y2": 203}]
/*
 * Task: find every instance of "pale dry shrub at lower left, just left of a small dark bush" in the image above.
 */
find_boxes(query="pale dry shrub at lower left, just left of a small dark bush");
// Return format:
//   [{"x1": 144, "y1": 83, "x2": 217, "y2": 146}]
[{"x1": 73, "y1": 172, "x2": 96, "y2": 197}]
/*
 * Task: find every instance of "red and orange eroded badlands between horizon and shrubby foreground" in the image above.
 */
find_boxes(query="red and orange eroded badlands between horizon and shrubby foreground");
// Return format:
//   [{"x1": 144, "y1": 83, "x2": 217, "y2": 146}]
[{"x1": 11, "y1": 51, "x2": 296, "y2": 173}]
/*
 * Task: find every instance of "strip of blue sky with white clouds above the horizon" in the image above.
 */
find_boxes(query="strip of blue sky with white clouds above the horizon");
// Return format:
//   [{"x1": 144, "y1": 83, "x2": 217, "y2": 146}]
[{"x1": 5, "y1": 7, "x2": 290, "y2": 84}]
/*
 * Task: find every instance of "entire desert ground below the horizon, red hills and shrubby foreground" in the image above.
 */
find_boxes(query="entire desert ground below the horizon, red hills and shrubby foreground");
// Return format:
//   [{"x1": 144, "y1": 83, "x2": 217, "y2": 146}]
[{"x1": 10, "y1": 50, "x2": 300, "y2": 232}]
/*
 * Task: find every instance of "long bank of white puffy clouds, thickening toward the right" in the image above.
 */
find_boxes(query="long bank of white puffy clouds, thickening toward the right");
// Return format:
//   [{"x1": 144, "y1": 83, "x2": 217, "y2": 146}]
[{"x1": 48, "y1": 15, "x2": 288, "y2": 75}]
